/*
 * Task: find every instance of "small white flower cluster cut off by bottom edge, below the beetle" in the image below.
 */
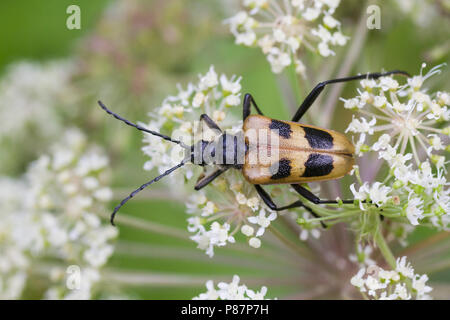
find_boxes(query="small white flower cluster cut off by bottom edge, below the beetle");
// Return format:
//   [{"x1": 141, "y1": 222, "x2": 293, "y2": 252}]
[{"x1": 193, "y1": 275, "x2": 267, "y2": 300}]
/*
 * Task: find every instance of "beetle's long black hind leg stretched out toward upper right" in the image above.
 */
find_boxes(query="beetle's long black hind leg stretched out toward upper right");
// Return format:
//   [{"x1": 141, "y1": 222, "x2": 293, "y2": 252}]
[{"x1": 292, "y1": 70, "x2": 410, "y2": 122}]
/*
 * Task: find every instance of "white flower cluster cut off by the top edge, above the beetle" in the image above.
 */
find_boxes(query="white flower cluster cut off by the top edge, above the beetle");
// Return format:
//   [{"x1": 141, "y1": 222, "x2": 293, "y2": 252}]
[{"x1": 226, "y1": 0, "x2": 347, "y2": 74}]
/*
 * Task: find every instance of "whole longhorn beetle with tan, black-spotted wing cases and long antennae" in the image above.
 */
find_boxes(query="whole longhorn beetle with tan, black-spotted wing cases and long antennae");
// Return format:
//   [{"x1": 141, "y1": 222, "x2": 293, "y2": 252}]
[{"x1": 98, "y1": 70, "x2": 409, "y2": 227}]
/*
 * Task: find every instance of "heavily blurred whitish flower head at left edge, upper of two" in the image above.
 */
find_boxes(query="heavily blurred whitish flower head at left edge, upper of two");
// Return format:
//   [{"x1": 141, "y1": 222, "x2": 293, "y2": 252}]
[{"x1": 0, "y1": 60, "x2": 75, "y2": 175}]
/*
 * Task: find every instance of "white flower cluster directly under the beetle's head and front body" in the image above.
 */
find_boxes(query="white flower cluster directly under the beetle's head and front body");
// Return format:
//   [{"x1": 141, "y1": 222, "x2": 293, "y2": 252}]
[{"x1": 143, "y1": 66, "x2": 284, "y2": 257}]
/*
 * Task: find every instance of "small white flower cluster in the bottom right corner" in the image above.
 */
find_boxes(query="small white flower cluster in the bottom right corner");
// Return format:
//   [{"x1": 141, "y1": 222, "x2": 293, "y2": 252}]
[{"x1": 350, "y1": 257, "x2": 433, "y2": 300}]
